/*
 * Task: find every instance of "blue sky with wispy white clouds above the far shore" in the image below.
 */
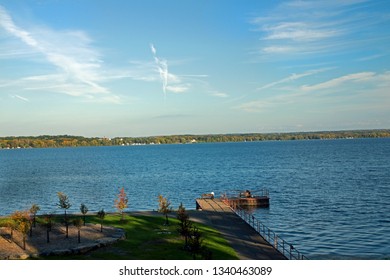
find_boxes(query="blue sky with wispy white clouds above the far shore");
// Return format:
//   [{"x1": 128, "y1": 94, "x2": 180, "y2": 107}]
[{"x1": 0, "y1": 0, "x2": 390, "y2": 137}]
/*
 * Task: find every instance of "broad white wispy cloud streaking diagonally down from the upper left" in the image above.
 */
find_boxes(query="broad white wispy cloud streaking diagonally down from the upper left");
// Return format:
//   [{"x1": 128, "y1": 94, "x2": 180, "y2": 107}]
[{"x1": 0, "y1": 6, "x2": 119, "y2": 102}]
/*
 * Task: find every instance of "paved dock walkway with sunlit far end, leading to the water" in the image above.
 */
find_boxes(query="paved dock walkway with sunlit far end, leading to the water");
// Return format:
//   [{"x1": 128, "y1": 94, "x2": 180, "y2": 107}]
[{"x1": 190, "y1": 199, "x2": 286, "y2": 260}]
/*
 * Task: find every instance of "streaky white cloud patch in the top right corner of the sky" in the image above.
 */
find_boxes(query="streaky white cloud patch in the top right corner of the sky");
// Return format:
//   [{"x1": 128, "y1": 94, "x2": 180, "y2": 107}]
[{"x1": 251, "y1": 0, "x2": 389, "y2": 58}]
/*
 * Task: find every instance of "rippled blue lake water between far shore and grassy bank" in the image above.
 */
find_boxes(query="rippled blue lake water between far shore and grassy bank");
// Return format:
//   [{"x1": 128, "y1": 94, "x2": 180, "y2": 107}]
[{"x1": 0, "y1": 139, "x2": 390, "y2": 259}]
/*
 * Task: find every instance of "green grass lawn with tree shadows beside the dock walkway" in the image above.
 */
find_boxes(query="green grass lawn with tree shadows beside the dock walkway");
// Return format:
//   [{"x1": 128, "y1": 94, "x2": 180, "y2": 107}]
[{"x1": 0, "y1": 214, "x2": 238, "y2": 260}]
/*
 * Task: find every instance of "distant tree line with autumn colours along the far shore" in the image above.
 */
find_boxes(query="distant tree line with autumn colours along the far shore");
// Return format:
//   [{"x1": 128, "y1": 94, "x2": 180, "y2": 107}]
[{"x1": 0, "y1": 129, "x2": 390, "y2": 149}]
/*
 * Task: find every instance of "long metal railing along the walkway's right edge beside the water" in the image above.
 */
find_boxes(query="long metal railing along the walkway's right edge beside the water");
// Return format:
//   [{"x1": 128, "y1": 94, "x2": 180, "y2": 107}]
[{"x1": 222, "y1": 199, "x2": 308, "y2": 260}]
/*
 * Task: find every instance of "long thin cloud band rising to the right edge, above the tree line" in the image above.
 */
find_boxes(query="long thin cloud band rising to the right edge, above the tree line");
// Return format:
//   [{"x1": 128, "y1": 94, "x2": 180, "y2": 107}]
[{"x1": 237, "y1": 71, "x2": 390, "y2": 112}]
